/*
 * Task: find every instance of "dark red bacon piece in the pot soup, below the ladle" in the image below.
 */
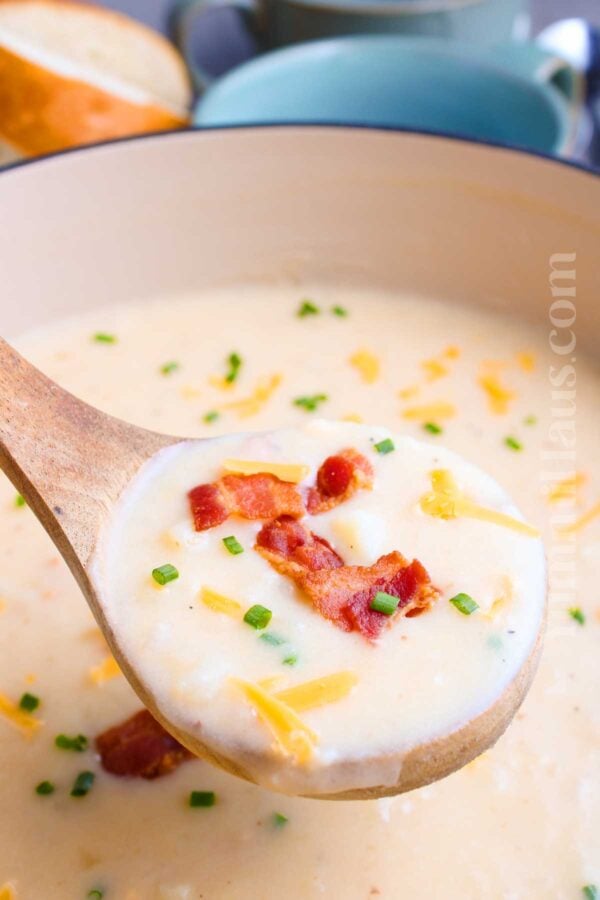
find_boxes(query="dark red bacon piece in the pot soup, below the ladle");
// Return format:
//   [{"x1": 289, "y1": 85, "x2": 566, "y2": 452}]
[{"x1": 96, "y1": 709, "x2": 193, "y2": 778}]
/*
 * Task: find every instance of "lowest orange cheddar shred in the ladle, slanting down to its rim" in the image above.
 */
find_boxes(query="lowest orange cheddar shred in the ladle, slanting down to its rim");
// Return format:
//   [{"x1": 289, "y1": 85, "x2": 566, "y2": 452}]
[{"x1": 231, "y1": 678, "x2": 318, "y2": 765}]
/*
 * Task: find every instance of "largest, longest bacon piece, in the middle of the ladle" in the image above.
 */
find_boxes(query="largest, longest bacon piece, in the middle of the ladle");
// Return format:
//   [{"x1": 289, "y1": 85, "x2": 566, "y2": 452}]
[{"x1": 256, "y1": 516, "x2": 438, "y2": 639}]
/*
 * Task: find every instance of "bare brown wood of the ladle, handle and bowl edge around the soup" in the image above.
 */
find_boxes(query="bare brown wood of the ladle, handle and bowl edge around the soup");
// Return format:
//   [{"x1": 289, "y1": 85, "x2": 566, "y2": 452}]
[{"x1": 0, "y1": 338, "x2": 541, "y2": 799}]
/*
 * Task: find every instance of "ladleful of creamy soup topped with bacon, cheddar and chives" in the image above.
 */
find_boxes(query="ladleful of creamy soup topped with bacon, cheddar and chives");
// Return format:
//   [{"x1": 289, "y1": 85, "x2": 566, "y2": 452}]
[{"x1": 95, "y1": 422, "x2": 546, "y2": 793}]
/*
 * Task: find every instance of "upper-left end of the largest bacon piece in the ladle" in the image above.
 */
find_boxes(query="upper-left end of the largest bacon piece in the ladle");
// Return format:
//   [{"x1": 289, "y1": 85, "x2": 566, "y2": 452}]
[{"x1": 255, "y1": 516, "x2": 344, "y2": 581}]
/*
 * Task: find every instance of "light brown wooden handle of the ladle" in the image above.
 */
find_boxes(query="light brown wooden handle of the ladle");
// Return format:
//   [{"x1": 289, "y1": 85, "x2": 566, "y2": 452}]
[{"x1": 0, "y1": 338, "x2": 174, "y2": 580}]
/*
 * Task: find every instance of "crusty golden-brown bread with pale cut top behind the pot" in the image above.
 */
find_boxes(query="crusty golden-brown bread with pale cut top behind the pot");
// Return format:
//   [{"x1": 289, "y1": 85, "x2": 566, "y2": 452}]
[{"x1": 0, "y1": 0, "x2": 191, "y2": 160}]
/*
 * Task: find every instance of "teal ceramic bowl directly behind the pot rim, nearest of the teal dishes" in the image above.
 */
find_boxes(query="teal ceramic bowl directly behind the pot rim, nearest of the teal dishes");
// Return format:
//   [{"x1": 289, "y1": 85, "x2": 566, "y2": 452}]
[{"x1": 194, "y1": 35, "x2": 579, "y2": 154}]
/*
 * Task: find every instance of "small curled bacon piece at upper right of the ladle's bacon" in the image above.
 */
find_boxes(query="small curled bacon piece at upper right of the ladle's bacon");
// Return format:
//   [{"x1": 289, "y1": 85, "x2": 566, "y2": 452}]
[{"x1": 306, "y1": 448, "x2": 373, "y2": 516}]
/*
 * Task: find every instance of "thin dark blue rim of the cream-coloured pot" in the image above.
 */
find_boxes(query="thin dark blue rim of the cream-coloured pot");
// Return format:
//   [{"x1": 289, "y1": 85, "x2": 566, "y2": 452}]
[{"x1": 0, "y1": 121, "x2": 600, "y2": 179}]
